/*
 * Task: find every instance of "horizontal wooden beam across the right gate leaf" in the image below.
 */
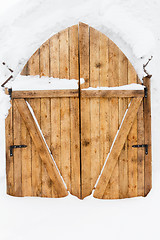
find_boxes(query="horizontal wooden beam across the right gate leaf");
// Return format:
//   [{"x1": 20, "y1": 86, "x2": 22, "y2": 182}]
[{"x1": 81, "y1": 90, "x2": 144, "y2": 98}]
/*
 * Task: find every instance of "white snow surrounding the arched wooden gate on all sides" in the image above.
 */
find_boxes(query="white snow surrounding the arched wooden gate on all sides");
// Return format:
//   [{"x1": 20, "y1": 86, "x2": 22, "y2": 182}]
[{"x1": 0, "y1": 0, "x2": 160, "y2": 240}]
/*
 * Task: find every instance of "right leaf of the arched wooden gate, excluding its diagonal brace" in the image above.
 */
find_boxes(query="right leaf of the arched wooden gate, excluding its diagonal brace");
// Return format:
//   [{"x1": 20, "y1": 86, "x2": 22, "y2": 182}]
[{"x1": 79, "y1": 23, "x2": 151, "y2": 199}]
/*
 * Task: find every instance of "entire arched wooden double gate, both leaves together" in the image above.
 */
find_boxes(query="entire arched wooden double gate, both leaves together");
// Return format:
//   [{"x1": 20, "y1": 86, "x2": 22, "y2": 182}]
[{"x1": 6, "y1": 23, "x2": 151, "y2": 199}]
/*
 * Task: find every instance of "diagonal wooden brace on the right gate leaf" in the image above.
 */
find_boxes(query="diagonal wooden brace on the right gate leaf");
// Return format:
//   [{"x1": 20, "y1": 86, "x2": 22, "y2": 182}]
[{"x1": 93, "y1": 98, "x2": 143, "y2": 198}]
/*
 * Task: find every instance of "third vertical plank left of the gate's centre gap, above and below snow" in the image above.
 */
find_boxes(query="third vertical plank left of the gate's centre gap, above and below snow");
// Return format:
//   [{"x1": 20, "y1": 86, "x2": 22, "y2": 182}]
[{"x1": 49, "y1": 34, "x2": 61, "y2": 197}]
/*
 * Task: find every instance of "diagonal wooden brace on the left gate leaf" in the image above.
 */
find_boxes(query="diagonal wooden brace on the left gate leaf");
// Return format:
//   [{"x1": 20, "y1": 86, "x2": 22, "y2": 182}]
[{"x1": 14, "y1": 99, "x2": 68, "y2": 197}]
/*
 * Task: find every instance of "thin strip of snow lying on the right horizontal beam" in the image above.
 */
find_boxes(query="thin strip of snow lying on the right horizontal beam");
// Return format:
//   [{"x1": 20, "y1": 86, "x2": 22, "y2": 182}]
[{"x1": 82, "y1": 83, "x2": 145, "y2": 91}]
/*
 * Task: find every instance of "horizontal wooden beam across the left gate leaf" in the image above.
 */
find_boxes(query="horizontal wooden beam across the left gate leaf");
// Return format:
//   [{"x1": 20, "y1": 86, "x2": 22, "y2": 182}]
[{"x1": 12, "y1": 89, "x2": 79, "y2": 99}]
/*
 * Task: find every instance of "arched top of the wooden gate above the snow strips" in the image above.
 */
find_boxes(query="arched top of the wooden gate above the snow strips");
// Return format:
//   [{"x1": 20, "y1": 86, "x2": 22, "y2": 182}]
[{"x1": 21, "y1": 22, "x2": 140, "y2": 88}]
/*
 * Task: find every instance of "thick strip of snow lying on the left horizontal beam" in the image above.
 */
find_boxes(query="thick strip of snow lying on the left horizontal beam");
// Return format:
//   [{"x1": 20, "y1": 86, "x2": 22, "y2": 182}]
[{"x1": 5, "y1": 74, "x2": 80, "y2": 91}]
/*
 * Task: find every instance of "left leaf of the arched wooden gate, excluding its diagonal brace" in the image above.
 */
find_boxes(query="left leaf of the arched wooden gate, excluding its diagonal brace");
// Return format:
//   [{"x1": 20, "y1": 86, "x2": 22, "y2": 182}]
[{"x1": 6, "y1": 26, "x2": 80, "y2": 198}]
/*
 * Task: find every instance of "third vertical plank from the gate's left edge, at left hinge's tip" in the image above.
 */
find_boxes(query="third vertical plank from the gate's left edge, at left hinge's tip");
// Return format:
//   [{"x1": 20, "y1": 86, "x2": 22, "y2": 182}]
[{"x1": 21, "y1": 100, "x2": 32, "y2": 196}]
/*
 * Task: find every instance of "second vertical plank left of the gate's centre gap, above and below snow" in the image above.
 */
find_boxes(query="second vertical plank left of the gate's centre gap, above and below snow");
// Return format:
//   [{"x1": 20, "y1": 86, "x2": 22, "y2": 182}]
[{"x1": 59, "y1": 28, "x2": 71, "y2": 191}]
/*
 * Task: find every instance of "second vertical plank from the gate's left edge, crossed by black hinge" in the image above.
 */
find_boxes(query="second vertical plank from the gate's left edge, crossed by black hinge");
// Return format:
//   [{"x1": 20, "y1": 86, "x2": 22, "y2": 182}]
[{"x1": 13, "y1": 101, "x2": 22, "y2": 197}]
